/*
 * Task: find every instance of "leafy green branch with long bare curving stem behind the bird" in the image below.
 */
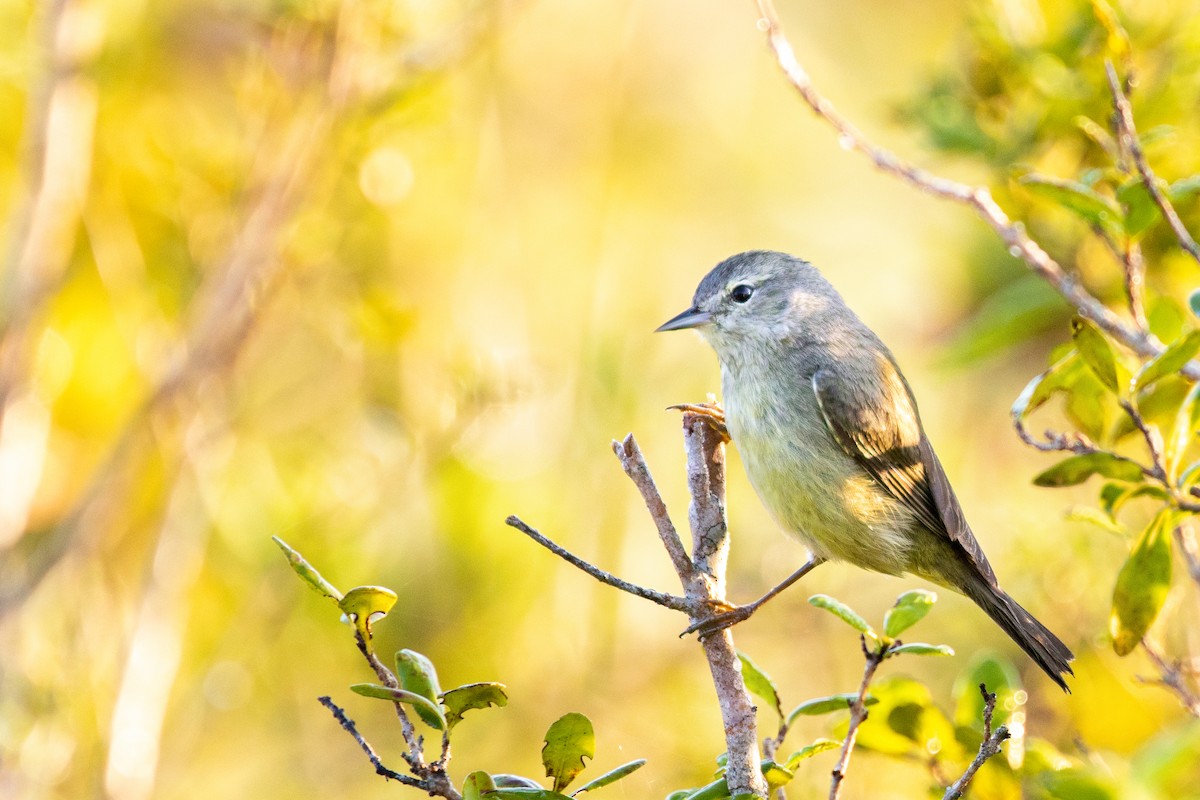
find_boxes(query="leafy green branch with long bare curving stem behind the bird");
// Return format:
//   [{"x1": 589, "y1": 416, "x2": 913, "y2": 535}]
[{"x1": 756, "y1": 0, "x2": 1200, "y2": 715}]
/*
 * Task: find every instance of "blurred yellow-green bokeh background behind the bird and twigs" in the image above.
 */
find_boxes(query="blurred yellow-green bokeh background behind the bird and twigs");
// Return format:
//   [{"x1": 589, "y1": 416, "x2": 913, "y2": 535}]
[{"x1": 0, "y1": 0, "x2": 1195, "y2": 800}]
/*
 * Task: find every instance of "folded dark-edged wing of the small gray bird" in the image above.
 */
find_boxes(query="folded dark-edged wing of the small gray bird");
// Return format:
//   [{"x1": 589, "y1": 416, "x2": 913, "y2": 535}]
[{"x1": 812, "y1": 354, "x2": 996, "y2": 583}]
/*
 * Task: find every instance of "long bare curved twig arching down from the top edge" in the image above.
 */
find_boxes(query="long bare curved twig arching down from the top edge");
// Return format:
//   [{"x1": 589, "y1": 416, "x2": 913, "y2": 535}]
[{"x1": 756, "y1": 0, "x2": 1200, "y2": 380}]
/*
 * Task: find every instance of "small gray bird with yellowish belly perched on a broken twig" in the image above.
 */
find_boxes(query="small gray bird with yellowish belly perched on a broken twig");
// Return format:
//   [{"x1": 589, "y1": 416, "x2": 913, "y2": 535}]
[{"x1": 658, "y1": 251, "x2": 1074, "y2": 691}]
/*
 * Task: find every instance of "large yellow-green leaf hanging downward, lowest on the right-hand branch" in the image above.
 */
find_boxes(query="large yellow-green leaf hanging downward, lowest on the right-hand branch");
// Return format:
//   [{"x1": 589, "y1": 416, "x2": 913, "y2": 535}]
[{"x1": 1109, "y1": 510, "x2": 1172, "y2": 656}]
